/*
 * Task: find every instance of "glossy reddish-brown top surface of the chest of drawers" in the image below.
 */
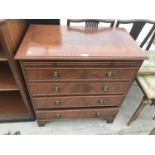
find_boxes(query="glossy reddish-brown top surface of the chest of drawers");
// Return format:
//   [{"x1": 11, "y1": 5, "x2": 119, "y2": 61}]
[{"x1": 16, "y1": 25, "x2": 146, "y2": 60}]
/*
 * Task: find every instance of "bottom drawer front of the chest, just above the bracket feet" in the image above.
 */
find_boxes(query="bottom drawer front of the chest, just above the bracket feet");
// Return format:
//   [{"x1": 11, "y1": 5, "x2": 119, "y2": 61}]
[{"x1": 36, "y1": 108, "x2": 118, "y2": 120}]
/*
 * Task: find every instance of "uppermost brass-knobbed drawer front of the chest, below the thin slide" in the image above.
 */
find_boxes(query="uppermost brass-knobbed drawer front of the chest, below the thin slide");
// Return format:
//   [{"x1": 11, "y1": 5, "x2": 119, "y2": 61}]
[{"x1": 26, "y1": 68, "x2": 137, "y2": 81}]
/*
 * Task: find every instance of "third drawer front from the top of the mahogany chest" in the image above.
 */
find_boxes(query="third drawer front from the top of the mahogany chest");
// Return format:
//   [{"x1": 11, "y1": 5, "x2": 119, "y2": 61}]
[{"x1": 33, "y1": 95, "x2": 124, "y2": 109}]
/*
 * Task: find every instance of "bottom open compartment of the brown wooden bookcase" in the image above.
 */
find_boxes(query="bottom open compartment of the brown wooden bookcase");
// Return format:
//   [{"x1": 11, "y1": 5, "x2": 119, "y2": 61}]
[{"x1": 0, "y1": 91, "x2": 29, "y2": 121}]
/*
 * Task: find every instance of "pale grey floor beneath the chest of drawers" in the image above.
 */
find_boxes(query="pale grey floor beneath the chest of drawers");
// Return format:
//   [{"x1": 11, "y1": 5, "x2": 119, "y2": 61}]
[{"x1": 0, "y1": 83, "x2": 155, "y2": 135}]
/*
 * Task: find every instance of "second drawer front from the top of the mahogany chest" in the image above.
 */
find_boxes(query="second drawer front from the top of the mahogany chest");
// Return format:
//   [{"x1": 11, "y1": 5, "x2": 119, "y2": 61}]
[{"x1": 29, "y1": 82, "x2": 131, "y2": 96}]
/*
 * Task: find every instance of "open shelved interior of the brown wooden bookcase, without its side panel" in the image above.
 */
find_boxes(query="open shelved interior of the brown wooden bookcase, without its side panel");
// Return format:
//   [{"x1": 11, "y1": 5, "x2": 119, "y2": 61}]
[{"x1": 0, "y1": 45, "x2": 29, "y2": 122}]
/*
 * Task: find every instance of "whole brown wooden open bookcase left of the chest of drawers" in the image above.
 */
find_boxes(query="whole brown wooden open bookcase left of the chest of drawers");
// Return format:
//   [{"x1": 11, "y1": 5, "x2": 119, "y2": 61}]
[{"x1": 0, "y1": 20, "x2": 34, "y2": 122}]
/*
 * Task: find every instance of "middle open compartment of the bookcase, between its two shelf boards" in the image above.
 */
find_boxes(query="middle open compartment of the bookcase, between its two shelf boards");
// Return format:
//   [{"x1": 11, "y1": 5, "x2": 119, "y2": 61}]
[{"x1": 0, "y1": 62, "x2": 18, "y2": 92}]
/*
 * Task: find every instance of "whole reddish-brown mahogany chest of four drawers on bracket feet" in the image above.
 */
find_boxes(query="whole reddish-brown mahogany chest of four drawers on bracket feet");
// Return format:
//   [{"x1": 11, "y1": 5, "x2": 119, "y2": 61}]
[{"x1": 16, "y1": 25, "x2": 146, "y2": 126}]
